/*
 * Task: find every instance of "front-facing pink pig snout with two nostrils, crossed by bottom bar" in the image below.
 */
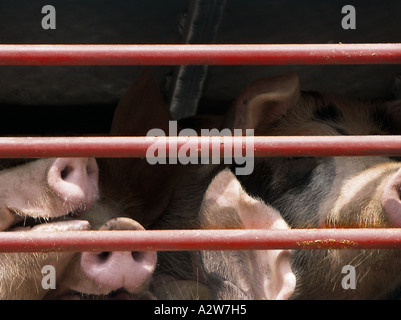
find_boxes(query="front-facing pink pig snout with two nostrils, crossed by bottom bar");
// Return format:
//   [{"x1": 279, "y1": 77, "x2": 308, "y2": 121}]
[{"x1": 81, "y1": 218, "x2": 157, "y2": 294}]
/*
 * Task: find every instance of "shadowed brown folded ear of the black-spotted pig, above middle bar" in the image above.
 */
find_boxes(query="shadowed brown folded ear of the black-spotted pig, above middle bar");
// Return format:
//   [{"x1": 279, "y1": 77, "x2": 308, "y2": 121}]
[{"x1": 230, "y1": 73, "x2": 300, "y2": 129}]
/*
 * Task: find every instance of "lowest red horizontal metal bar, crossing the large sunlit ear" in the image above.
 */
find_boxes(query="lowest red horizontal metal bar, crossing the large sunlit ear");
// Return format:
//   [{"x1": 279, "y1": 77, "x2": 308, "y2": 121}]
[{"x1": 0, "y1": 228, "x2": 401, "y2": 252}]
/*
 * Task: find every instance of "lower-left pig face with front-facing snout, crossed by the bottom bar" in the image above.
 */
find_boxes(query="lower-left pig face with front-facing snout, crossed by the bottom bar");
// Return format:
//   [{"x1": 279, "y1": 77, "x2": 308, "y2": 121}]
[{"x1": 0, "y1": 216, "x2": 157, "y2": 300}]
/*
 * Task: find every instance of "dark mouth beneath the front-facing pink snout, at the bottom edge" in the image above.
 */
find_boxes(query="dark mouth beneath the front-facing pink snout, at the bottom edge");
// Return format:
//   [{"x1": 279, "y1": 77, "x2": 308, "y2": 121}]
[{"x1": 57, "y1": 289, "x2": 156, "y2": 300}]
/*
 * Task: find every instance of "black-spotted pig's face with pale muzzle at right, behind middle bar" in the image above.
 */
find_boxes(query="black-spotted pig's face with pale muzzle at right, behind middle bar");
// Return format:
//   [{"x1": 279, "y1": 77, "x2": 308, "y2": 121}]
[{"x1": 230, "y1": 75, "x2": 401, "y2": 228}]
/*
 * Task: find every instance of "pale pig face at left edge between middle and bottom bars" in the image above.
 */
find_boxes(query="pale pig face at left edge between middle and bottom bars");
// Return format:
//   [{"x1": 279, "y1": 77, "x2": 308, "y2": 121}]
[{"x1": 0, "y1": 158, "x2": 98, "y2": 231}]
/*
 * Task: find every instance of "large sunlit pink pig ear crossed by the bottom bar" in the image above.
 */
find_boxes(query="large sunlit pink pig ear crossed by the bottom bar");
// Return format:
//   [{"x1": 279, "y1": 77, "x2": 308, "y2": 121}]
[{"x1": 201, "y1": 170, "x2": 296, "y2": 299}]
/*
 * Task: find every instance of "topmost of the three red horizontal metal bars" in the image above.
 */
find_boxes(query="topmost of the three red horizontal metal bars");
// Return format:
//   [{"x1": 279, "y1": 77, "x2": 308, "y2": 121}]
[{"x1": 0, "y1": 43, "x2": 401, "y2": 65}]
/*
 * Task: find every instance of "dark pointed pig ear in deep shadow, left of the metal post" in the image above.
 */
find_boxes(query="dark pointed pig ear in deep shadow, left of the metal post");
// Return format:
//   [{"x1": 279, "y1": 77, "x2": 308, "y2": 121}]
[{"x1": 110, "y1": 68, "x2": 171, "y2": 136}]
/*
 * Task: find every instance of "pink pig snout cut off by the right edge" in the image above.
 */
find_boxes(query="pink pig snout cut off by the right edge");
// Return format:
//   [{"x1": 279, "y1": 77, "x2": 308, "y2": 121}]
[{"x1": 381, "y1": 169, "x2": 401, "y2": 227}]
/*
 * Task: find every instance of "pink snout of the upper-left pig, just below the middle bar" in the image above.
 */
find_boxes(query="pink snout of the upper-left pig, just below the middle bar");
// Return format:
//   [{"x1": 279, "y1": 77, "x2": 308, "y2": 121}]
[{"x1": 47, "y1": 158, "x2": 98, "y2": 210}]
